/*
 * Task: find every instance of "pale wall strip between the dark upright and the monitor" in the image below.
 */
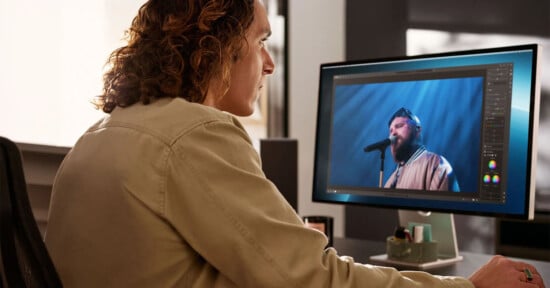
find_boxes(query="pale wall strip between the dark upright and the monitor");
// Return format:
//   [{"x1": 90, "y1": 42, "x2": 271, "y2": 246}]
[{"x1": 287, "y1": 0, "x2": 345, "y2": 236}]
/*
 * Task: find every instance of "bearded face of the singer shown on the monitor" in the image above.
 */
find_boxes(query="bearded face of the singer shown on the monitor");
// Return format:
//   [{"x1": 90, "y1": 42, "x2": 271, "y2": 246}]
[{"x1": 390, "y1": 117, "x2": 420, "y2": 162}]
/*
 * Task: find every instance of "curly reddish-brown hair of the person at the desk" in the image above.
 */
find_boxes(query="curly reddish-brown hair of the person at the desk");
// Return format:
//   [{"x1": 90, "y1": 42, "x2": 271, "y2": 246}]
[{"x1": 95, "y1": 0, "x2": 254, "y2": 113}]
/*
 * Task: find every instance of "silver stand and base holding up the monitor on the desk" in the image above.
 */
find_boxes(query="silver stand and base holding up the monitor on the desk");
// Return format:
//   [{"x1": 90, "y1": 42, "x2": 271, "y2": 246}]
[{"x1": 370, "y1": 210, "x2": 463, "y2": 270}]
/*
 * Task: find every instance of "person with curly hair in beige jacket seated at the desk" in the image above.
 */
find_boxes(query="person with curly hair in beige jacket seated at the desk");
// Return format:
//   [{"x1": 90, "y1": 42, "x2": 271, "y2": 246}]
[{"x1": 45, "y1": 0, "x2": 542, "y2": 288}]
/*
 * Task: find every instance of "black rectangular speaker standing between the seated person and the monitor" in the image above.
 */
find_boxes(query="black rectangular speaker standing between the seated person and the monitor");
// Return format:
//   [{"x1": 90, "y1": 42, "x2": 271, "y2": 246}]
[{"x1": 260, "y1": 138, "x2": 298, "y2": 211}]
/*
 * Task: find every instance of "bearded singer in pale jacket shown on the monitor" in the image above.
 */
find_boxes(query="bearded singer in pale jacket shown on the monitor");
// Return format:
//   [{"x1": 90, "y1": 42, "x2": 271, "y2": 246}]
[{"x1": 384, "y1": 108, "x2": 460, "y2": 192}]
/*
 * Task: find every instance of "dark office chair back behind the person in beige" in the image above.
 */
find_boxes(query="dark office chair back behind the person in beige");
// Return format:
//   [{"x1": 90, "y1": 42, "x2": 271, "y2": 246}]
[{"x1": 0, "y1": 137, "x2": 62, "y2": 288}]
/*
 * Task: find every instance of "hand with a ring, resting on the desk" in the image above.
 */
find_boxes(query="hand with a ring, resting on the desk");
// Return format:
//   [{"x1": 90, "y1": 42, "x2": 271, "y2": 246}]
[{"x1": 469, "y1": 255, "x2": 545, "y2": 288}]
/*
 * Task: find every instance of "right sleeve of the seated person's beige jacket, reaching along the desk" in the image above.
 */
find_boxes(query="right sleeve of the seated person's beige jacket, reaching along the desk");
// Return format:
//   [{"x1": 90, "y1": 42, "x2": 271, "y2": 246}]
[{"x1": 165, "y1": 120, "x2": 473, "y2": 288}]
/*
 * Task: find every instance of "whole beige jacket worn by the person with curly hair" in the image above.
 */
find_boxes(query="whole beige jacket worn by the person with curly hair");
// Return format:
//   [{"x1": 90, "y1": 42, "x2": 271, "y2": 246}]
[{"x1": 46, "y1": 99, "x2": 472, "y2": 288}]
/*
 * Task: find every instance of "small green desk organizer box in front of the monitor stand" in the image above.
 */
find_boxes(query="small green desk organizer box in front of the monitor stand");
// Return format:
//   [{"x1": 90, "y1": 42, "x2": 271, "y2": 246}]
[{"x1": 386, "y1": 236, "x2": 438, "y2": 263}]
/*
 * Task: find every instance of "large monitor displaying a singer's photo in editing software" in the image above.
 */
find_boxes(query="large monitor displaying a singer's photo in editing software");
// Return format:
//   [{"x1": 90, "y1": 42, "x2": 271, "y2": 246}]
[{"x1": 313, "y1": 44, "x2": 541, "y2": 219}]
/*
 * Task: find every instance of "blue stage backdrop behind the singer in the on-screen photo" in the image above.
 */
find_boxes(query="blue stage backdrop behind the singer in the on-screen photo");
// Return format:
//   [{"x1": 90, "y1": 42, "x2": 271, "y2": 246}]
[{"x1": 329, "y1": 77, "x2": 484, "y2": 192}]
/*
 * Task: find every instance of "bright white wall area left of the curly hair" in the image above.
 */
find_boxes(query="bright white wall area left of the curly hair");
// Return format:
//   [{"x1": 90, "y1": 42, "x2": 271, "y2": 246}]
[{"x1": 0, "y1": 0, "x2": 145, "y2": 146}]
